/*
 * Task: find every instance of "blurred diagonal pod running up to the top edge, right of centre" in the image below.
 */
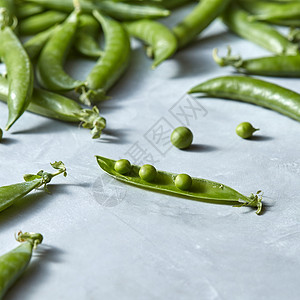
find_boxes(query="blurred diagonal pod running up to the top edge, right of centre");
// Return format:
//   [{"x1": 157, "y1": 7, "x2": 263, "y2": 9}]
[{"x1": 173, "y1": 0, "x2": 230, "y2": 48}]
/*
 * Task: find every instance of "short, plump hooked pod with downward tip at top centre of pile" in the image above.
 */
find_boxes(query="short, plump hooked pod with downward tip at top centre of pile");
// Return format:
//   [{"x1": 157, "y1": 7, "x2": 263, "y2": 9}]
[{"x1": 123, "y1": 20, "x2": 177, "y2": 69}]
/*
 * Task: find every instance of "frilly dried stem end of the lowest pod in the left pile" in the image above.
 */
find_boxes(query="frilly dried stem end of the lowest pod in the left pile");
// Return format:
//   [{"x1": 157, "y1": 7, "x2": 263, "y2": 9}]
[{"x1": 75, "y1": 106, "x2": 106, "y2": 139}]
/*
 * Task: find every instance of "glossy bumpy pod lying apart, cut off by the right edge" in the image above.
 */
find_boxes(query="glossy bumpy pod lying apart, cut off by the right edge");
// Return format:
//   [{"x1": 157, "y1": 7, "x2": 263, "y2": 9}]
[{"x1": 188, "y1": 76, "x2": 300, "y2": 121}]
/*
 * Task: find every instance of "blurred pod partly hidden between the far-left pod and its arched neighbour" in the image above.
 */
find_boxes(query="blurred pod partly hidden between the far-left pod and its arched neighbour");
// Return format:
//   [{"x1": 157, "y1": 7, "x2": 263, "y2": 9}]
[{"x1": 23, "y1": 25, "x2": 60, "y2": 60}]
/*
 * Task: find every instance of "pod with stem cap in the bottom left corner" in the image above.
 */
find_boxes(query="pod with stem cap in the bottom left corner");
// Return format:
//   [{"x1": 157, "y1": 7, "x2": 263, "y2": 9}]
[{"x1": 0, "y1": 231, "x2": 43, "y2": 299}]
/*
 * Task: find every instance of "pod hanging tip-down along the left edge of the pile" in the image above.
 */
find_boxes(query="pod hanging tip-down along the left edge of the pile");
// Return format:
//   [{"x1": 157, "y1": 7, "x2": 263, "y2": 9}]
[{"x1": 0, "y1": 8, "x2": 33, "y2": 130}]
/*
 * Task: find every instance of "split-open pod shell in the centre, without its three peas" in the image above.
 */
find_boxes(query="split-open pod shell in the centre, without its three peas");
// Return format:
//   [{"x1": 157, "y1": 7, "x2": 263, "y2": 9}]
[{"x1": 96, "y1": 156, "x2": 262, "y2": 214}]
